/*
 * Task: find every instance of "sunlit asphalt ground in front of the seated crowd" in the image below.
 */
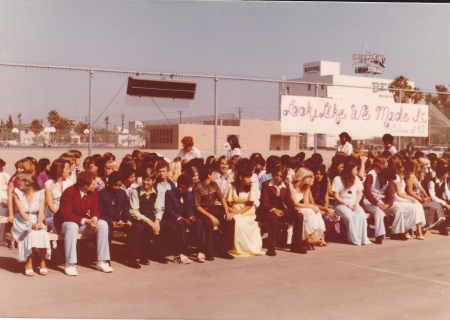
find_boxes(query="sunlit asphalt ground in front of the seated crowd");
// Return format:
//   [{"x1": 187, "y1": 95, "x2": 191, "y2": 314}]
[{"x1": 0, "y1": 229, "x2": 450, "y2": 319}]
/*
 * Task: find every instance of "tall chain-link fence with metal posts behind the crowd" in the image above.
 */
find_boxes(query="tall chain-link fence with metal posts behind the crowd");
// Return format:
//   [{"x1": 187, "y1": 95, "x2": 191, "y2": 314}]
[{"x1": 0, "y1": 63, "x2": 450, "y2": 171}]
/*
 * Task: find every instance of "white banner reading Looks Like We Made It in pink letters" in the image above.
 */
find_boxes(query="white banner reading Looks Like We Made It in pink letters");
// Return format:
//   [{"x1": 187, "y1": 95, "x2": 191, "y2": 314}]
[{"x1": 281, "y1": 96, "x2": 428, "y2": 137}]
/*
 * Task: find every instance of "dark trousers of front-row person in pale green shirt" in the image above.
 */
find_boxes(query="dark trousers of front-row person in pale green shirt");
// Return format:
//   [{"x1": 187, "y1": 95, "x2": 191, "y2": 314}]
[{"x1": 130, "y1": 220, "x2": 175, "y2": 259}]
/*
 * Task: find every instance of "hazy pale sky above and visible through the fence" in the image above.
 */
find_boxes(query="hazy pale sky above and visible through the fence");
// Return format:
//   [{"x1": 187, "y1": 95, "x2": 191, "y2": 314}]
[{"x1": 0, "y1": 0, "x2": 450, "y2": 129}]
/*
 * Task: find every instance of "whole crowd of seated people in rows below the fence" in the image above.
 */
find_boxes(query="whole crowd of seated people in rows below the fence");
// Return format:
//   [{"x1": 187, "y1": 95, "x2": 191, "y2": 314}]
[{"x1": 0, "y1": 132, "x2": 450, "y2": 276}]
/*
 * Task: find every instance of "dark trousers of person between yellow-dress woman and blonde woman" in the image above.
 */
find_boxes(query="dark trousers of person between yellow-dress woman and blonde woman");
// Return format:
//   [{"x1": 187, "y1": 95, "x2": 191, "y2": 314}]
[{"x1": 258, "y1": 208, "x2": 303, "y2": 248}]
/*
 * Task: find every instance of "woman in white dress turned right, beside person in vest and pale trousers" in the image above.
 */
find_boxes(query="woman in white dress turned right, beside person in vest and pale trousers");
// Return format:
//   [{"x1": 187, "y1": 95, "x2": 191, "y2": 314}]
[{"x1": 388, "y1": 157, "x2": 426, "y2": 240}]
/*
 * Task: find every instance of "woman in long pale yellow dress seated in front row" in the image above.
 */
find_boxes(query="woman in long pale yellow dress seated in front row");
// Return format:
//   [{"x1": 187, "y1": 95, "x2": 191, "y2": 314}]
[{"x1": 224, "y1": 166, "x2": 264, "y2": 257}]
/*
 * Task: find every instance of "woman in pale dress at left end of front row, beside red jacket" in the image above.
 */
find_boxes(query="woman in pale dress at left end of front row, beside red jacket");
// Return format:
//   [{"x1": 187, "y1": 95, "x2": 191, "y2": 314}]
[{"x1": 12, "y1": 172, "x2": 51, "y2": 276}]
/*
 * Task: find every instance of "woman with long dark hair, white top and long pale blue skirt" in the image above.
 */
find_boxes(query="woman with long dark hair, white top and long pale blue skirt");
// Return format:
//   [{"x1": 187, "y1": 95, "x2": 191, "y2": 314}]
[{"x1": 331, "y1": 161, "x2": 371, "y2": 246}]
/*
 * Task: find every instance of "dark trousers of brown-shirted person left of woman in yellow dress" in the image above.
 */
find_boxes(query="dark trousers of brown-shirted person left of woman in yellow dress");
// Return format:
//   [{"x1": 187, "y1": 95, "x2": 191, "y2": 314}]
[{"x1": 197, "y1": 206, "x2": 235, "y2": 254}]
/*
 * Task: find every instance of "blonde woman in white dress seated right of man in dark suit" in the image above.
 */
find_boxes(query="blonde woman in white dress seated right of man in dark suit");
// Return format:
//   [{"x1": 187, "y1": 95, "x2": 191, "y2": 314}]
[{"x1": 289, "y1": 167, "x2": 326, "y2": 249}]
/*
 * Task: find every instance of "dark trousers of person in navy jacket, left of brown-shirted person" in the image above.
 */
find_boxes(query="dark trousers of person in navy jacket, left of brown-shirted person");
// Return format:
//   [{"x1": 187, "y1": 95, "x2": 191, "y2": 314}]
[{"x1": 163, "y1": 219, "x2": 204, "y2": 256}]
